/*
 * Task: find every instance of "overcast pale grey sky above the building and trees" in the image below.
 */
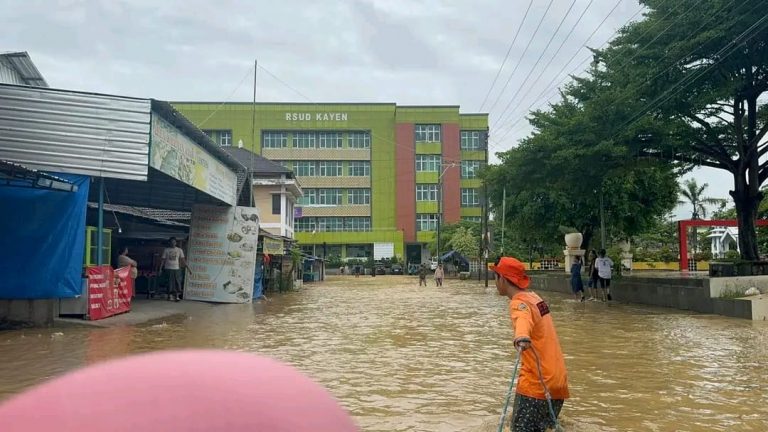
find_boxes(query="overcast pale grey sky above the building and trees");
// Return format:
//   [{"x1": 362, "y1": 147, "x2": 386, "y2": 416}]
[{"x1": 0, "y1": 0, "x2": 732, "y2": 215}]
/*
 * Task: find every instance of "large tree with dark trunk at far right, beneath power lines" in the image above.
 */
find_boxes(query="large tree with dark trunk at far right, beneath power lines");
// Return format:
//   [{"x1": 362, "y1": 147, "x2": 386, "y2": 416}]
[{"x1": 582, "y1": 0, "x2": 768, "y2": 260}]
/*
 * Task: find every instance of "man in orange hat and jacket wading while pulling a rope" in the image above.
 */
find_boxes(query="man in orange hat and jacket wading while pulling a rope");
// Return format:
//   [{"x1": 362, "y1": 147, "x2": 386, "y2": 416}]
[{"x1": 491, "y1": 257, "x2": 569, "y2": 432}]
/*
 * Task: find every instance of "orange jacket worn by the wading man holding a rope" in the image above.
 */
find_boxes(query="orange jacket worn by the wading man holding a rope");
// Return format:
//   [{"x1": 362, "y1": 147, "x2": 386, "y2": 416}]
[{"x1": 509, "y1": 291, "x2": 570, "y2": 399}]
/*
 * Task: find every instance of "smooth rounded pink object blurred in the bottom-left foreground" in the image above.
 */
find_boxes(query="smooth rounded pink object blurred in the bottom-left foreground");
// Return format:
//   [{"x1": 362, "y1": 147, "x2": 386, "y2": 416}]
[{"x1": 0, "y1": 351, "x2": 359, "y2": 432}]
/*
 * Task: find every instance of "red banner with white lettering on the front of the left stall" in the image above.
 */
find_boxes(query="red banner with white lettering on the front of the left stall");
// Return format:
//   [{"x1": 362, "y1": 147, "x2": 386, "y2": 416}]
[{"x1": 87, "y1": 265, "x2": 133, "y2": 320}]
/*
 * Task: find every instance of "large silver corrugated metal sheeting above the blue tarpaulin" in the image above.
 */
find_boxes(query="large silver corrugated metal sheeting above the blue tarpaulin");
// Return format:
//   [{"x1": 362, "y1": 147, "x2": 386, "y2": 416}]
[{"x1": 0, "y1": 84, "x2": 150, "y2": 181}]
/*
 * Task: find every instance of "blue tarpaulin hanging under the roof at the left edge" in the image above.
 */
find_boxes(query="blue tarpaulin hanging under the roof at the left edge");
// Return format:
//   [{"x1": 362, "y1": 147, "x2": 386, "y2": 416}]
[{"x1": 0, "y1": 174, "x2": 90, "y2": 299}]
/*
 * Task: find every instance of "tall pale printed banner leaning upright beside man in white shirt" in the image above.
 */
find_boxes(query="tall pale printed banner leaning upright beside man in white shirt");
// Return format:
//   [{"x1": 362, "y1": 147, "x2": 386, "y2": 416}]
[{"x1": 184, "y1": 204, "x2": 259, "y2": 303}]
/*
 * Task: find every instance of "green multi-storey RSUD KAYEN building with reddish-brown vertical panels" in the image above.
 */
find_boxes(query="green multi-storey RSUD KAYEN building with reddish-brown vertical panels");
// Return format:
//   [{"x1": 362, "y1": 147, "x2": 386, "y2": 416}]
[{"x1": 174, "y1": 102, "x2": 488, "y2": 262}]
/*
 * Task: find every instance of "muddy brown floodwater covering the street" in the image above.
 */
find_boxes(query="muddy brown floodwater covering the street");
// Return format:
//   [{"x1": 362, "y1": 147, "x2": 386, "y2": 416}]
[{"x1": 0, "y1": 276, "x2": 768, "y2": 432}]
